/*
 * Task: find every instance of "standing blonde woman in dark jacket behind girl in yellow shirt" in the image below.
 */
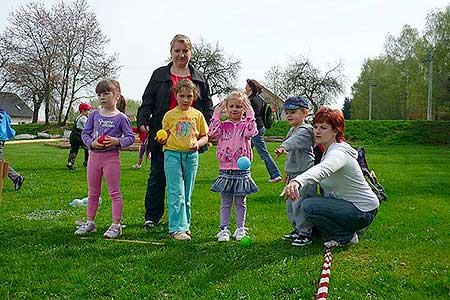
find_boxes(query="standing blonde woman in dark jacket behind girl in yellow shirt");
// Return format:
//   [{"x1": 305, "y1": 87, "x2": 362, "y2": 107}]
[{"x1": 137, "y1": 34, "x2": 213, "y2": 229}]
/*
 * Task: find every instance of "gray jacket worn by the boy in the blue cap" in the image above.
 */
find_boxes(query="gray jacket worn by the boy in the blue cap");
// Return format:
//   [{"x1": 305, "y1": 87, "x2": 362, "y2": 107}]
[{"x1": 281, "y1": 124, "x2": 315, "y2": 175}]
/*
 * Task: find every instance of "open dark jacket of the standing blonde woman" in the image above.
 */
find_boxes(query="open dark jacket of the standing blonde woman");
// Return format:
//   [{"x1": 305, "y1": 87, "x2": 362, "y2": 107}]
[{"x1": 137, "y1": 62, "x2": 214, "y2": 152}]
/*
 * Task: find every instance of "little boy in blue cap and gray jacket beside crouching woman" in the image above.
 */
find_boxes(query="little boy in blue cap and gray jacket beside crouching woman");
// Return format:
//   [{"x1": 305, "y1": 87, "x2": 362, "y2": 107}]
[{"x1": 275, "y1": 96, "x2": 317, "y2": 246}]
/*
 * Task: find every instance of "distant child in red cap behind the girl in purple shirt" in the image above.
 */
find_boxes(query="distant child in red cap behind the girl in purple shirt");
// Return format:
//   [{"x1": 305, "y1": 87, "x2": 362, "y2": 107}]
[{"x1": 66, "y1": 103, "x2": 93, "y2": 170}]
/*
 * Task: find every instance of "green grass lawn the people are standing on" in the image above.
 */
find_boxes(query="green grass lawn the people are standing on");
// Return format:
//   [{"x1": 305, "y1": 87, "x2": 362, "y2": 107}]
[{"x1": 0, "y1": 143, "x2": 450, "y2": 299}]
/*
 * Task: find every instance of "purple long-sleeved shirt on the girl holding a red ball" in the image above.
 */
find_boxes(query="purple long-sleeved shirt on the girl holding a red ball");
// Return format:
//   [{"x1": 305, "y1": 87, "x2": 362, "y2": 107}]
[{"x1": 81, "y1": 110, "x2": 134, "y2": 152}]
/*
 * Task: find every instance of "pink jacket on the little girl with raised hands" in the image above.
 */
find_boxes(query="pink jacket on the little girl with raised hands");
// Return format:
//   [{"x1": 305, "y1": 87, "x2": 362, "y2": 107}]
[{"x1": 208, "y1": 110, "x2": 258, "y2": 170}]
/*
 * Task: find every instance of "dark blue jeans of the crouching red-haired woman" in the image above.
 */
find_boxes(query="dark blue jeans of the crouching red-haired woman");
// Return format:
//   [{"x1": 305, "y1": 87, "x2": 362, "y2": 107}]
[{"x1": 301, "y1": 197, "x2": 377, "y2": 244}]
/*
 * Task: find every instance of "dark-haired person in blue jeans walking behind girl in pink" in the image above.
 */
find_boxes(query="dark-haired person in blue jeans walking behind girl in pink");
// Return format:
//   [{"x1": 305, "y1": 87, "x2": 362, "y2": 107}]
[{"x1": 245, "y1": 79, "x2": 282, "y2": 182}]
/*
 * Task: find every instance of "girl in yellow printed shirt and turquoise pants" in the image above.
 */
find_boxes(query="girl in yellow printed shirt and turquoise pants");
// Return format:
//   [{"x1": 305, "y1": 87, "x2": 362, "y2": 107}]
[{"x1": 155, "y1": 79, "x2": 208, "y2": 241}]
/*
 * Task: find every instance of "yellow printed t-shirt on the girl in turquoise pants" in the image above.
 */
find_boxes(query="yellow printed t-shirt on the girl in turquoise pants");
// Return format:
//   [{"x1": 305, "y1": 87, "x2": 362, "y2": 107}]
[{"x1": 162, "y1": 106, "x2": 208, "y2": 152}]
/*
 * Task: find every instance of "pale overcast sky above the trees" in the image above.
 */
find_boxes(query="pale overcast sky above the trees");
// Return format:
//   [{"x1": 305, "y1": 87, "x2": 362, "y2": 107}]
[{"x1": 0, "y1": 0, "x2": 450, "y2": 108}]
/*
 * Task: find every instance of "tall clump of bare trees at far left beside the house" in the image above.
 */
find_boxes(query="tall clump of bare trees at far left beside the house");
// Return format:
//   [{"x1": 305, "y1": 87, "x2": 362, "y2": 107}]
[{"x1": 0, "y1": 0, "x2": 119, "y2": 125}]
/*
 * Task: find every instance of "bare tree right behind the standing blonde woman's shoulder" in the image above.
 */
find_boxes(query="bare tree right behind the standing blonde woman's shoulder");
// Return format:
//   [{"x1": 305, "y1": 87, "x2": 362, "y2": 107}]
[{"x1": 191, "y1": 39, "x2": 241, "y2": 96}]
